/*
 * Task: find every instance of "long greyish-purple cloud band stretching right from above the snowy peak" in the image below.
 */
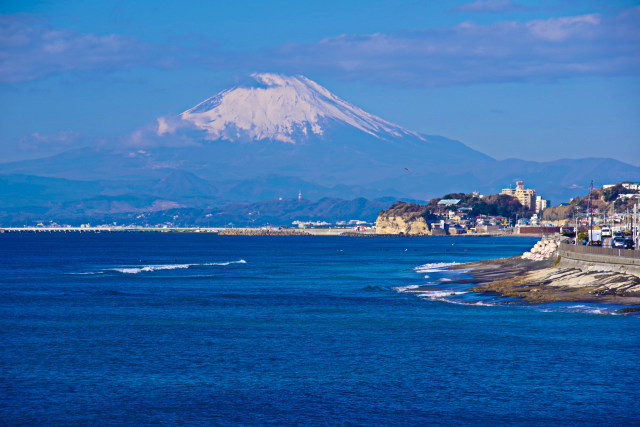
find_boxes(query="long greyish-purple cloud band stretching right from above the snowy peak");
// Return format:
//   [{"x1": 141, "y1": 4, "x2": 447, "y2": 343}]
[{"x1": 248, "y1": 7, "x2": 640, "y2": 86}]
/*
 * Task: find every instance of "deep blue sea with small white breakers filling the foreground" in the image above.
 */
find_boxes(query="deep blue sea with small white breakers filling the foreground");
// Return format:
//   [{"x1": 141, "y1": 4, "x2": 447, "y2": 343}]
[{"x1": 0, "y1": 233, "x2": 640, "y2": 425}]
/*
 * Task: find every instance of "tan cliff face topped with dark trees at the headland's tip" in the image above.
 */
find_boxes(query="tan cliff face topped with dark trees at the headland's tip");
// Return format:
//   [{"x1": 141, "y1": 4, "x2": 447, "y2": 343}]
[{"x1": 376, "y1": 202, "x2": 431, "y2": 236}]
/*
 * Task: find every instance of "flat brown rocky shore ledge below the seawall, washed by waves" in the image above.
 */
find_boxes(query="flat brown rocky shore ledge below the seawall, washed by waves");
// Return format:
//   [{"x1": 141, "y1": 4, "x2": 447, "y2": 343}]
[{"x1": 449, "y1": 256, "x2": 640, "y2": 312}]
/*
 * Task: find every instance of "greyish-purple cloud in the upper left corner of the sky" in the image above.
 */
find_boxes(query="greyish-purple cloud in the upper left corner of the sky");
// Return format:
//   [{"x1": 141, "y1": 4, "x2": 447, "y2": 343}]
[{"x1": 0, "y1": 14, "x2": 153, "y2": 83}]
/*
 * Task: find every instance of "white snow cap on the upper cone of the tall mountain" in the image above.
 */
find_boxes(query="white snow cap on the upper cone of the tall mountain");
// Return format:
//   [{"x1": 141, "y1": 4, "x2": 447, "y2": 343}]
[{"x1": 178, "y1": 73, "x2": 422, "y2": 143}]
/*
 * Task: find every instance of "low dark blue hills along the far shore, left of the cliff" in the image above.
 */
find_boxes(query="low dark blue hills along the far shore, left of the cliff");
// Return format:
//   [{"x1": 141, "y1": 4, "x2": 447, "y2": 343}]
[{"x1": 0, "y1": 195, "x2": 395, "y2": 227}]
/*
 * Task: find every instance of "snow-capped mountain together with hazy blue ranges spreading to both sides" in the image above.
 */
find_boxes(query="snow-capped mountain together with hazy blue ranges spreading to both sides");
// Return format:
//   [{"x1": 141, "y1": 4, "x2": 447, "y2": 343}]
[{"x1": 0, "y1": 74, "x2": 640, "y2": 224}]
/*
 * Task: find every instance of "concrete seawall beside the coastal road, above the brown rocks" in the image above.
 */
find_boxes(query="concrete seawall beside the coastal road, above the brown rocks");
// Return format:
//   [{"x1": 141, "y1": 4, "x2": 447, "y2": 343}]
[{"x1": 558, "y1": 244, "x2": 640, "y2": 277}]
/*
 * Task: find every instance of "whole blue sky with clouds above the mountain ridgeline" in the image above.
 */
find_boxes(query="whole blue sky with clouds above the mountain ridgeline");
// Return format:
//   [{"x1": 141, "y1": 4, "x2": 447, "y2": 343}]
[{"x1": 0, "y1": 0, "x2": 640, "y2": 165}]
